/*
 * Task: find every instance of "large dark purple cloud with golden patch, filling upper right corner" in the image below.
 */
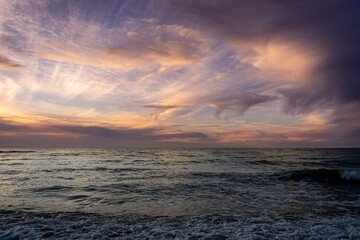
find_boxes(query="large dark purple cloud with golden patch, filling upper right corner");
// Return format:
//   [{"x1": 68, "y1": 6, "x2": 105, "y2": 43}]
[{"x1": 172, "y1": 0, "x2": 360, "y2": 114}]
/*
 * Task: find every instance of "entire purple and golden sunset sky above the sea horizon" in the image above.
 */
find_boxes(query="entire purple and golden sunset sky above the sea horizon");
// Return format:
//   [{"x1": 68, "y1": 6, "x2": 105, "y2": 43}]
[{"x1": 0, "y1": 0, "x2": 360, "y2": 147}]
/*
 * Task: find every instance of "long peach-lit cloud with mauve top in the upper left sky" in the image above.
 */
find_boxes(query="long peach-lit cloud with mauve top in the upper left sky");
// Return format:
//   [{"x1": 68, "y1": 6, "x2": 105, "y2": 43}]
[{"x1": 2, "y1": 18, "x2": 208, "y2": 71}]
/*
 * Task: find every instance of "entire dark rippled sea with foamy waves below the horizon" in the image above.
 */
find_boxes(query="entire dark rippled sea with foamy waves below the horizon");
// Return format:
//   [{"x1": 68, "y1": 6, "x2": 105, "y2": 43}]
[{"x1": 0, "y1": 148, "x2": 360, "y2": 240}]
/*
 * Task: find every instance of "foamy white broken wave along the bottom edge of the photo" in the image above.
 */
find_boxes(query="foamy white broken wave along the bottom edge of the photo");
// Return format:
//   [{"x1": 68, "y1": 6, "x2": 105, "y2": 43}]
[{"x1": 0, "y1": 211, "x2": 360, "y2": 240}]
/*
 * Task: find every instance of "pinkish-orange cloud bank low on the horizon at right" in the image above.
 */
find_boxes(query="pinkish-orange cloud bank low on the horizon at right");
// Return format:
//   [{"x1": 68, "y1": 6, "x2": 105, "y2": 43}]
[{"x1": 221, "y1": 103, "x2": 360, "y2": 147}]
